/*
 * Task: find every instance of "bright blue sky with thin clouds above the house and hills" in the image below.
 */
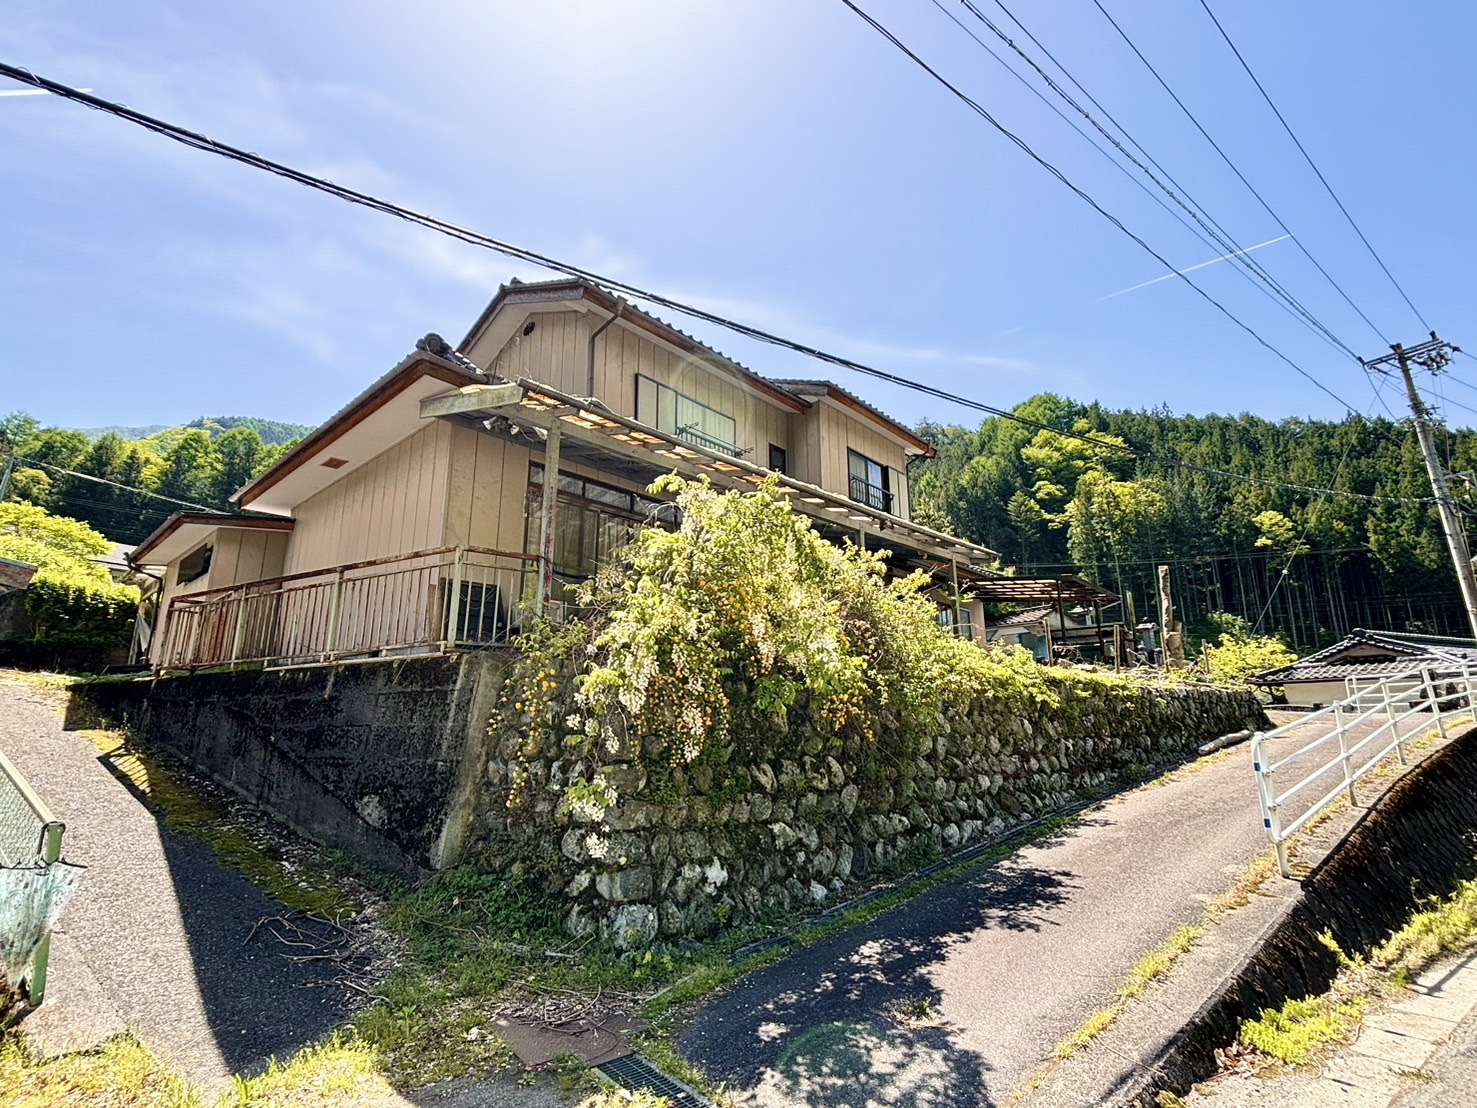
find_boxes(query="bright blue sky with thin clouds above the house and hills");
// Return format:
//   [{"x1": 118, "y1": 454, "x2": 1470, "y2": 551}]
[{"x1": 0, "y1": 0, "x2": 1477, "y2": 425}]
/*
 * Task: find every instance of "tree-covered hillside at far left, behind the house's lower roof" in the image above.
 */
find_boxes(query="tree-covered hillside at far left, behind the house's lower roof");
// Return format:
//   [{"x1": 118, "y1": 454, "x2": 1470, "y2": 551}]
[{"x1": 0, "y1": 412, "x2": 306, "y2": 545}]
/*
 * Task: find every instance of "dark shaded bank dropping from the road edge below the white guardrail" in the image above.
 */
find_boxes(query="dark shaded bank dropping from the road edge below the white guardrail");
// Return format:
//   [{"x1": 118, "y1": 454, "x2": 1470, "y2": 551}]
[{"x1": 1108, "y1": 730, "x2": 1477, "y2": 1108}]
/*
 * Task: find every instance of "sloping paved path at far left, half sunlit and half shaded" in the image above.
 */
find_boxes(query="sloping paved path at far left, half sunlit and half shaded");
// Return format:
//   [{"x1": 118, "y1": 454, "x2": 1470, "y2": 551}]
[{"x1": 0, "y1": 678, "x2": 347, "y2": 1086}]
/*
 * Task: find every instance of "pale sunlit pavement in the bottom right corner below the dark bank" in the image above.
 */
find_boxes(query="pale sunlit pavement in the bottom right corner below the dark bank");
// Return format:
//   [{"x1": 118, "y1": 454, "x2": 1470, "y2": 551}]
[{"x1": 1185, "y1": 950, "x2": 1477, "y2": 1108}]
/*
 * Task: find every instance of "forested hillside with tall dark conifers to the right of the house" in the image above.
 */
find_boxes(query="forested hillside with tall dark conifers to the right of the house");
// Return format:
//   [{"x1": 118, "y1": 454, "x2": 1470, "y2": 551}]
[{"x1": 911, "y1": 394, "x2": 1477, "y2": 649}]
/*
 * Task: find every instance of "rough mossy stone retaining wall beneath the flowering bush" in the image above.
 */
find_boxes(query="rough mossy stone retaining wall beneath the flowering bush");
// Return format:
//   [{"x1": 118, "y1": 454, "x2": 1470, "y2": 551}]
[{"x1": 477, "y1": 683, "x2": 1266, "y2": 947}]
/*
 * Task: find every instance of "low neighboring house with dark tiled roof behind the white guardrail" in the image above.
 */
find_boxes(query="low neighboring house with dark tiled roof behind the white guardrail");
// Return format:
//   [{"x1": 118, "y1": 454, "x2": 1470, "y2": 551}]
[{"x1": 1250, "y1": 628, "x2": 1477, "y2": 708}]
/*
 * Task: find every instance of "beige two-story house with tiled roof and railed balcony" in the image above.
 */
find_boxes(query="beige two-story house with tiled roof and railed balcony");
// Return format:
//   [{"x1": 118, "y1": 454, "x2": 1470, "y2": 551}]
[{"x1": 133, "y1": 279, "x2": 995, "y2": 668}]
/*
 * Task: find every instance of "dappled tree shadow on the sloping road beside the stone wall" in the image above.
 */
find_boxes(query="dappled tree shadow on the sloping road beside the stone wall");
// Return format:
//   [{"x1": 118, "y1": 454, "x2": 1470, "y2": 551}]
[{"x1": 679, "y1": 817, "x2": 1094, "y2": 1108}]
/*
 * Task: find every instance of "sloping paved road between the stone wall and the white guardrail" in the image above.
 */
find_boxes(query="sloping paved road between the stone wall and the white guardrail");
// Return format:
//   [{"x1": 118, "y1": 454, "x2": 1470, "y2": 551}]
[{"x1": 681, "y1": 715, "x2": 1406, "y2": 1108}]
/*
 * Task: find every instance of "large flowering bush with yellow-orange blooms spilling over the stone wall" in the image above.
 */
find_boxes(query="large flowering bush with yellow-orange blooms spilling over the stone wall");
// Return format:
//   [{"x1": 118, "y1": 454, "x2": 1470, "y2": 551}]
[{"x1": 498, "y1": 477, "x2": 1125, "y2": 818}]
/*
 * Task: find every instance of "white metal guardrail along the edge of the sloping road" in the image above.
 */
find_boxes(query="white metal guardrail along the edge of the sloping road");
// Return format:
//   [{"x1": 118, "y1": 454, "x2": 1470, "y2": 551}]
[{"x1": 1251, "y1": 663, "x2": 1477, "y2": 878}]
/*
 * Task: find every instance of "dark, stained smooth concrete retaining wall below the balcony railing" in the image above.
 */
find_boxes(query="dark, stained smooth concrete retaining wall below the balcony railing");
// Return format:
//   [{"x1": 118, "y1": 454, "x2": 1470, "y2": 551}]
[{"x1": 87, "y1": 652, "x2": 510, "y2": 870}]
